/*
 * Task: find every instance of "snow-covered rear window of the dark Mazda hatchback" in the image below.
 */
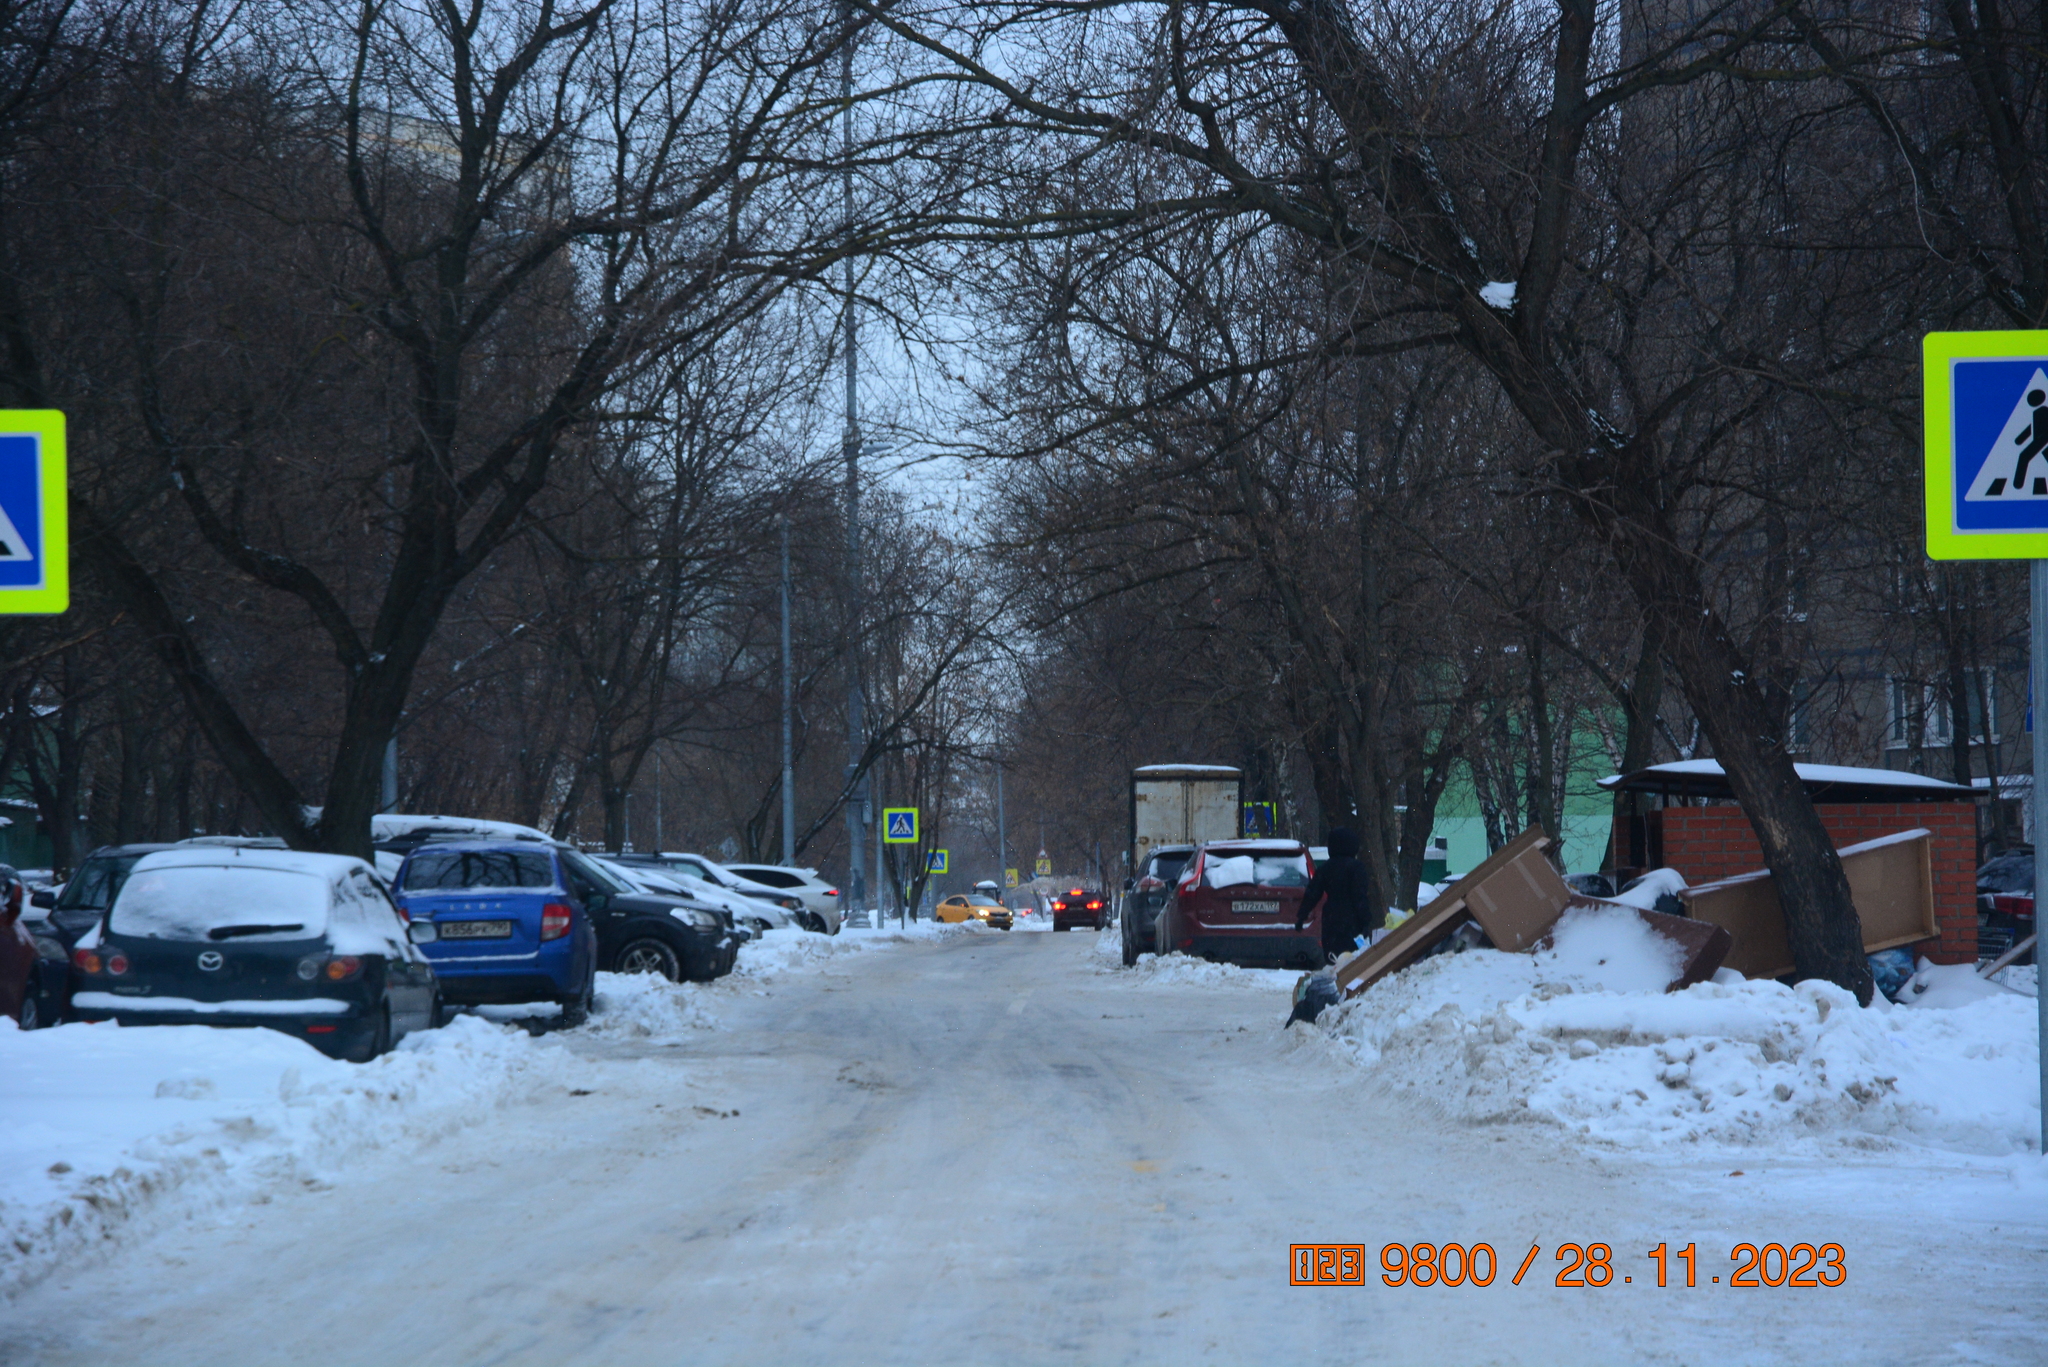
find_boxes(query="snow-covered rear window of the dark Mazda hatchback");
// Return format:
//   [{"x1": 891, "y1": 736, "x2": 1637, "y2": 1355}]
[{"x1": 106, "y1": 865, "x2": 328, "y2": 941}]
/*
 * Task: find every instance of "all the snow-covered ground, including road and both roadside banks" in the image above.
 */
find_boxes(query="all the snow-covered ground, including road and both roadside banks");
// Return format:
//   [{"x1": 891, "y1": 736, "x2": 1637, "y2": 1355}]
[{"x1": 0, "y1": 912, "x2": 2048, "y2": 1367}]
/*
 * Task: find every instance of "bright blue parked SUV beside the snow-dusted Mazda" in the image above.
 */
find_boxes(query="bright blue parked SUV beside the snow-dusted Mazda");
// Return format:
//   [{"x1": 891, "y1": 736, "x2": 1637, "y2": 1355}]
[{"x1": 395, "y1": 840, "x2": 598, "y2": 1025}]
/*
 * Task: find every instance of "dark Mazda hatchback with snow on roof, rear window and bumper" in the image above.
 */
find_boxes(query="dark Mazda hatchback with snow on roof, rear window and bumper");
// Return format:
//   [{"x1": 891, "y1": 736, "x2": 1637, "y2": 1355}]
[{"x1": 72, "y1": 846, "x2": 440, "y2": 1064}]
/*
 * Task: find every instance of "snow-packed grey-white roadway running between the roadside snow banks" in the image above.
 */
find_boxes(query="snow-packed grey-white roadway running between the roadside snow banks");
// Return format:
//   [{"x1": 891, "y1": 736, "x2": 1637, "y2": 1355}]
[{"x1": 0, "y1": 933, "x2": 2048, "y2": 1367}]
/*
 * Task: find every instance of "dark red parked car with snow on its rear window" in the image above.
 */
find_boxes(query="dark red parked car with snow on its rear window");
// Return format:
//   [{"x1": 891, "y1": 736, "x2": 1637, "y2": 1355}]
[{"x1": 1153, "y1": 840, "x2": 1323, "y2": 967}]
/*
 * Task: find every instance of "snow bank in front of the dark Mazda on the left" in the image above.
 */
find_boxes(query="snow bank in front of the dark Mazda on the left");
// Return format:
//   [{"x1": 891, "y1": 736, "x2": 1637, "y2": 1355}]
[{"x1": 0, "y1": 1017, "x2": 580, "y2": 1293}]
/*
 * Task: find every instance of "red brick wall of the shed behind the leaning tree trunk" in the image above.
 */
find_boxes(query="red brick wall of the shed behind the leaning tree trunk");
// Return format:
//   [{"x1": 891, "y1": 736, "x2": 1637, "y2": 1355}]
[{"x1": 1649, "y1": 801, "x2": 1976, "y2": 963}]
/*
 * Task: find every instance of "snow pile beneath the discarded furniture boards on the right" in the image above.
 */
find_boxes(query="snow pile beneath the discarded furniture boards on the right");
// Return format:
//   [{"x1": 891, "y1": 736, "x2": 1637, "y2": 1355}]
[{"x1": 1323, "y1": 949, "x2": 2040, "y2": 1154}]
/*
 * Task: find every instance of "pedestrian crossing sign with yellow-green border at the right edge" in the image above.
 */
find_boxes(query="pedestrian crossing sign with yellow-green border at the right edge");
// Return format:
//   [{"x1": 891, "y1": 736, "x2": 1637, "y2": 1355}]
[{"x1": 1921, "y1": 332, "x2": 2048, "y2": 560}]
